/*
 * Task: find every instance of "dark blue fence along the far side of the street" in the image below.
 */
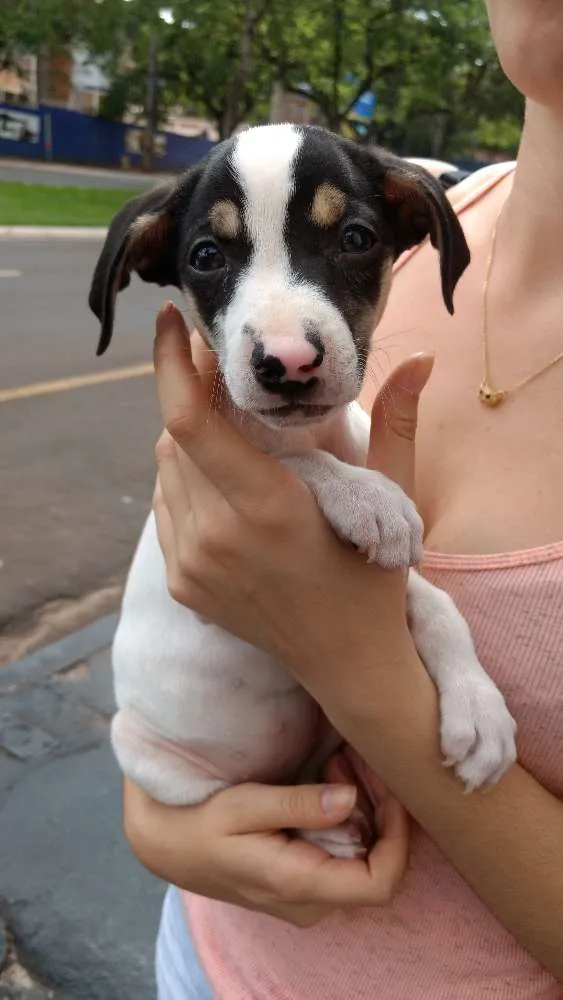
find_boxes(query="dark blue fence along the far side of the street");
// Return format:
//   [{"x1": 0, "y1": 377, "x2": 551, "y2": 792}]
[{"x1": 0, "y1": 104, "x2": 214, "y2": 172}]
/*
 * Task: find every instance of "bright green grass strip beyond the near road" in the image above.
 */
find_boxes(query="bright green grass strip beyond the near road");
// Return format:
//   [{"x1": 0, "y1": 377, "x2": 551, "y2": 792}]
[{"x1": 0, "y1": 181, "x2": 139, "y2": 226}]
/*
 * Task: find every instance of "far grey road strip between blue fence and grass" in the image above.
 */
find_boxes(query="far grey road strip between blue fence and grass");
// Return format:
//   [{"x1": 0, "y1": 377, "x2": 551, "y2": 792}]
[{"x1": 0, "y1": 158, "x2": 173, "y2": 190}]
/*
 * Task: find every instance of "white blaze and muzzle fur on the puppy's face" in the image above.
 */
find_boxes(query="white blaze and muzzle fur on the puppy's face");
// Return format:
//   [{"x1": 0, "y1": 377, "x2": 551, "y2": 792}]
[{"x1": 215, "y1": 125, "x2": 364, "y2": 420}]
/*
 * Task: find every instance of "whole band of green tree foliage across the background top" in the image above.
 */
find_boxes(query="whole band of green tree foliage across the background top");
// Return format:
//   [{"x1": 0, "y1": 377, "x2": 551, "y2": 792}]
[{"x1": 0, "y1": 0, "x2": 522, "y2": 156}]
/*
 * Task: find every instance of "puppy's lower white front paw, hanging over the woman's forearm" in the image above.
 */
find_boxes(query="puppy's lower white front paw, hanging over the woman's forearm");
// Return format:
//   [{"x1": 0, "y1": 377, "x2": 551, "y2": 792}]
[{"x1": 440, "y1": 664, "x2": 516, "y2": 792}]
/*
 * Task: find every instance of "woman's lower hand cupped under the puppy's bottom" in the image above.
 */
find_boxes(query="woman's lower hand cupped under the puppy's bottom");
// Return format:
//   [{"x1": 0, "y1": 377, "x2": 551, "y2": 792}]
[{"x1": 124, "y1": 755, "x2": 409, "y2": 927}]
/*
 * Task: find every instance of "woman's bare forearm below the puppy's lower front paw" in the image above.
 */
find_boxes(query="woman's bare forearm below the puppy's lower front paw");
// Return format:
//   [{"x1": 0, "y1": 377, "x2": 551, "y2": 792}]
[{"x1": 326, "y1": 652, "x2": 563, "y2": 982}]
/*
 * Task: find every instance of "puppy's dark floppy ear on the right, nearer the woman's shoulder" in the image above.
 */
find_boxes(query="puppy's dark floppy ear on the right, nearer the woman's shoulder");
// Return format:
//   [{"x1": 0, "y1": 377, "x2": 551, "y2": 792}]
[{"x1": 377, "y1": 152, "x2": 471, "y2": 313}]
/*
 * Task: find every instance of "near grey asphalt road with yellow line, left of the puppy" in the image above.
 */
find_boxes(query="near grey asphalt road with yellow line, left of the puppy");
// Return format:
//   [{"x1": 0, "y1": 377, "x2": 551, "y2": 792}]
[{"x1": 0, "y1": 239, "x2": 184, "y2": 662}]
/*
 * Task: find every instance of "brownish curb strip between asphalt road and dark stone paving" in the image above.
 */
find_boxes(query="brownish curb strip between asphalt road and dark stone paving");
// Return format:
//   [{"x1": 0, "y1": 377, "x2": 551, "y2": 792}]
[{"x1": 0, "y1": 612, "x2": 119, "y2": 691}]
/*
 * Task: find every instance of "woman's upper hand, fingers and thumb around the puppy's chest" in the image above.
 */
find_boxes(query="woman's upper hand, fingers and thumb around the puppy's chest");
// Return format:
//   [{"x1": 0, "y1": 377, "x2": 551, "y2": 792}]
[{"x1": 154, "y1": 303, "x2": 432, "y2": 703}]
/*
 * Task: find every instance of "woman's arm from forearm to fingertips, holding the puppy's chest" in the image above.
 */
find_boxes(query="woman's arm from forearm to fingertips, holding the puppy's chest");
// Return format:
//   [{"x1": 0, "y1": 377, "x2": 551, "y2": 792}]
[{"x1": 149, "y1": 298, "x2": 563, "y2": 981}]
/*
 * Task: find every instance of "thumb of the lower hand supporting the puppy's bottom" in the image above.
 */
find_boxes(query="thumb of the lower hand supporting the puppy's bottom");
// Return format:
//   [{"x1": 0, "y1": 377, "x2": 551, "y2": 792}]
[{"x1": 223, "y1": 784, "x2": 357, "y2": 834}]
